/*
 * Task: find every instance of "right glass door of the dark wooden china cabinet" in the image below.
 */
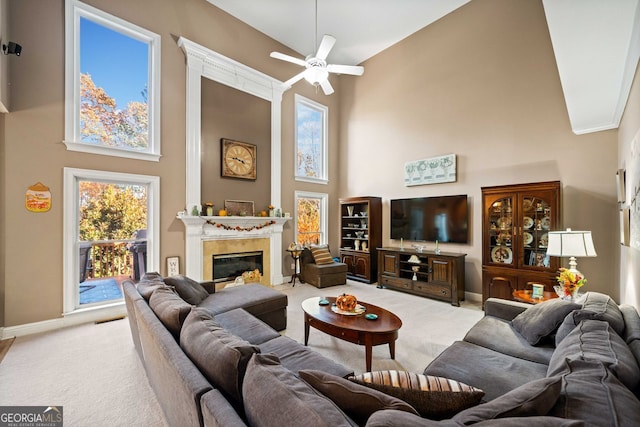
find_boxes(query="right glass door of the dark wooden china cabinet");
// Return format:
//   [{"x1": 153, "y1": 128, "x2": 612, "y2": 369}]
[{"x1": 519, "y1": 195, "x2": 557, "y2": 269}]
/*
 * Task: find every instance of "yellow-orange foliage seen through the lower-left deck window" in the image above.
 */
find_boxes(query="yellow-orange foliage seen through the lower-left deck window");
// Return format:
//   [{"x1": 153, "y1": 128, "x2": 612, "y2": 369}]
[{"x1": 80, "y1": 181, "x2": 147, "y2": 241}]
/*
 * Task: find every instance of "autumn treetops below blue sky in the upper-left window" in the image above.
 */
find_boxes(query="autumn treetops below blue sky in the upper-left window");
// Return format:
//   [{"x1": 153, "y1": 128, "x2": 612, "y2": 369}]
[{"x1": 80, "y1": 73, "x2": 149, "y2": 149}]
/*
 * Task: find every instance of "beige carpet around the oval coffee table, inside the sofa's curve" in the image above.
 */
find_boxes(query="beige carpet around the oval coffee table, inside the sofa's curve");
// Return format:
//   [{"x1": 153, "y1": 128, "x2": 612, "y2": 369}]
[{"x1": 275, "y1": 280, "x2": 484, "y2": 373}]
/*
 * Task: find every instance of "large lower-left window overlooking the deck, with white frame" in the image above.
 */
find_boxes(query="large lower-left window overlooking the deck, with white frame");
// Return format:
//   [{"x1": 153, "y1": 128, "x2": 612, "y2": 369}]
[{"x1": 63, "y1": 168, "x2": 160, "y2": 314}]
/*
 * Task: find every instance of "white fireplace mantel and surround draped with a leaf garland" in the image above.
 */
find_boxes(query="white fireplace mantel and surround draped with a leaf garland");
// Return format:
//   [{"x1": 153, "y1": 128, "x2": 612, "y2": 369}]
[{"x1": 178, "y1": 215, "x2": 291, "y2": 284}]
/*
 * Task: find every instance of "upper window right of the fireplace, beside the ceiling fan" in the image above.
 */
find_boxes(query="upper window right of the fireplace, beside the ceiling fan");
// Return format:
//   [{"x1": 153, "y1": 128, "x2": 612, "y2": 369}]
[{"x1": 295, "y1": 94, "x2": 329, "y2": 184}]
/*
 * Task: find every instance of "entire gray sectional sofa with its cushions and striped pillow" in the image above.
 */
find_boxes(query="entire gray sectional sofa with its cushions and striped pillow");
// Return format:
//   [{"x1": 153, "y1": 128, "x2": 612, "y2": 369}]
[{"x1": 124, "y1": 274, "x2": 640, "y2": 427}]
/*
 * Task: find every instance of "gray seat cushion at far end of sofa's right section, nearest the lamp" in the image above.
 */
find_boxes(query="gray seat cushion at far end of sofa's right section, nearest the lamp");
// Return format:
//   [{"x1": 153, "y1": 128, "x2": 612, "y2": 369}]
[{"x1": 464, "y1": 316, "x2": 555, "y2": 365}]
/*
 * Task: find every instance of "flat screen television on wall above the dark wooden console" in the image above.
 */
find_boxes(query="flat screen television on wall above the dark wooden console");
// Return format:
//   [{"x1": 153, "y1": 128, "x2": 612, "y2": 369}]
[{"x1": 389, "y1": 194, "x2": 469, "y2": 243}]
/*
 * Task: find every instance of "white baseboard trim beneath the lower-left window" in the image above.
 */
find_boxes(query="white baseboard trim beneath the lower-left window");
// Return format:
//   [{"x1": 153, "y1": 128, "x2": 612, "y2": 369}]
[{"x1": 0, "y1": 301, "x2": 127, "y2": 339}]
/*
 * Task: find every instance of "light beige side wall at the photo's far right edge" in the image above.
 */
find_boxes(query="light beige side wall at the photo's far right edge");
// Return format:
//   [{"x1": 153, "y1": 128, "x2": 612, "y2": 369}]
[{"x1": 618, "y1": 68, "x2": 640, "y2": 307}]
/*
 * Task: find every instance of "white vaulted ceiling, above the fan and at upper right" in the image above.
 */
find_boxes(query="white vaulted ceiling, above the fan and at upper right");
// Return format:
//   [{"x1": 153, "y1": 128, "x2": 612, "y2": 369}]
[{"x1": 207, "y1": 0, "x2": 640, "y2": 134}]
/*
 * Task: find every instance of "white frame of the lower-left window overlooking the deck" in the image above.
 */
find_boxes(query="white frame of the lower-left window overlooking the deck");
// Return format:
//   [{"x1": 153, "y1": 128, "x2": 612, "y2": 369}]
[{"x1": 63, "y1": 167, "x2": 160, "y2": 316}]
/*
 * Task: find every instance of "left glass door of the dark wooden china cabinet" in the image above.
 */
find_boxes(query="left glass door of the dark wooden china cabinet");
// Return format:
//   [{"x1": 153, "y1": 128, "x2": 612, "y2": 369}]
[{"x1": 488, "y1": 197, "x2": 515, "y2": 265}]
